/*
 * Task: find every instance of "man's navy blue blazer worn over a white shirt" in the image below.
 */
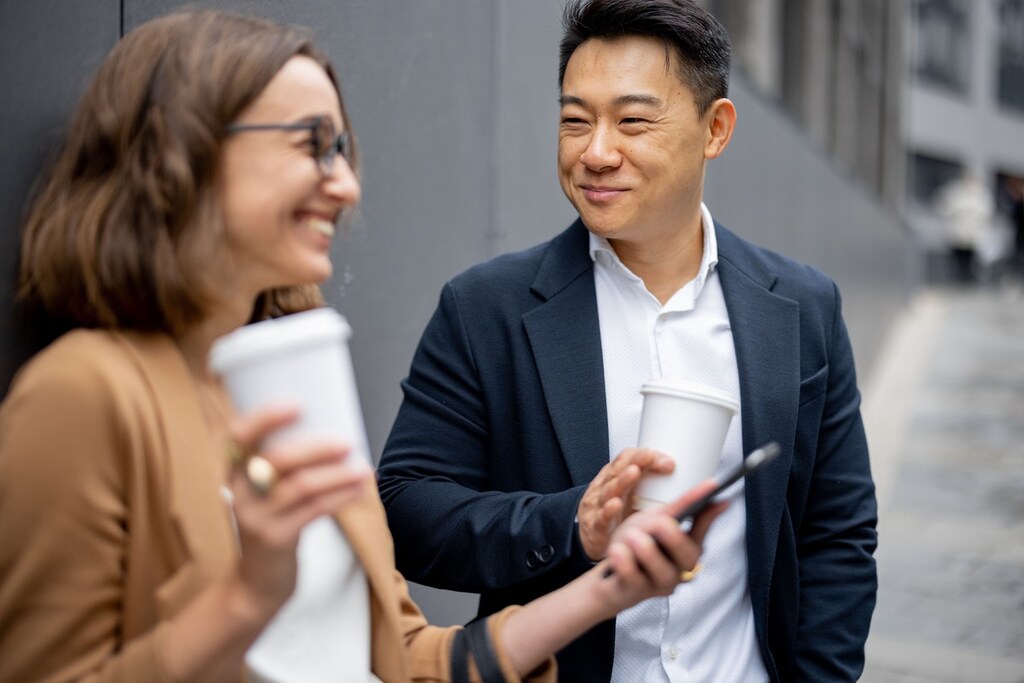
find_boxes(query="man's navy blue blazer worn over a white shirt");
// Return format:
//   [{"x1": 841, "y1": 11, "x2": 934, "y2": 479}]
[{"x1": 379, "y1": 220, "x2": 877, "y2": 682}]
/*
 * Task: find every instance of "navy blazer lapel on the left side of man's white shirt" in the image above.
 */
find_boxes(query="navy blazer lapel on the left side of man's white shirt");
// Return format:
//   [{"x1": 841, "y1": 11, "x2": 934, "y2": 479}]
[{"x1": 522, "y1": 220, "x2": 608, "y2": 485}]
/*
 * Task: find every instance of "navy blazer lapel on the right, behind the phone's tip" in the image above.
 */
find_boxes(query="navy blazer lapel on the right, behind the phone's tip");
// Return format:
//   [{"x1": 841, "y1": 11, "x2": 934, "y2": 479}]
[{"x1": 716, "y1": 225, "x2": 800, "y2": 599}]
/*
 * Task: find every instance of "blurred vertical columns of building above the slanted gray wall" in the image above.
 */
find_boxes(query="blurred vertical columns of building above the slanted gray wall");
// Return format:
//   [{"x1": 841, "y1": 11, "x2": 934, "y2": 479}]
[{"x1": 705, "y1": 0, "x2": 906, "y2": 210}]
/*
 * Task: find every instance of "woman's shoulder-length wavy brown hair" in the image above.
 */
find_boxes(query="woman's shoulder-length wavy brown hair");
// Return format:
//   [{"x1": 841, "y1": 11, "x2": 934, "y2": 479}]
[{"x1": 18, "y1": 10, "x2": 360, "y2": 335}]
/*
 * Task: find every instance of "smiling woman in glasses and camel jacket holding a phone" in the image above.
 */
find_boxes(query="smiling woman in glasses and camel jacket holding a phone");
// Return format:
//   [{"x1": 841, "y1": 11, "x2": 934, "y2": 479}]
[{"x1": 0, "y1": 11, "x2": 721, "y2": 682}]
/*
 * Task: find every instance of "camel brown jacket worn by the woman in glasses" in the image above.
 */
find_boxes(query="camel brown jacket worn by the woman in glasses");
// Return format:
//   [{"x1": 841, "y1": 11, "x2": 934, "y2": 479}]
[{"x1": 0, "y1": 330, "x2": 556, "y2": 683}]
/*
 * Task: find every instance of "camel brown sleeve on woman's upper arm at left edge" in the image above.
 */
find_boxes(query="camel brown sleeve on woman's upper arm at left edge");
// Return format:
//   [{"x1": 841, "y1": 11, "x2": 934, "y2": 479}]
[{"x1": 0, "y1": 342, "x2": 180, "y2": 683}]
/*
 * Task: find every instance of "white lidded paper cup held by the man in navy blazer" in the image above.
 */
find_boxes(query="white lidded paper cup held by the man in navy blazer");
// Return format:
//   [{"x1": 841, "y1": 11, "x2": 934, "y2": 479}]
[{"x1": 633, "y1": 379, "x2": 739, "y2": 509}]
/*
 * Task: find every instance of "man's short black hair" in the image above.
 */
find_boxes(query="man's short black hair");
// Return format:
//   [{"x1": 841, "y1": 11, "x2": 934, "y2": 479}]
[{"x1": 558, "y1": 0, "x2": 731, "y2": 115}]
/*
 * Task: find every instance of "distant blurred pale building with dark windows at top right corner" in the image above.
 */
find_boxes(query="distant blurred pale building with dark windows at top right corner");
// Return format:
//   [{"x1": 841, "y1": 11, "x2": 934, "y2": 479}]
[{"x1": 902, "y1": 0, "x2": 1024, "y2": 272}]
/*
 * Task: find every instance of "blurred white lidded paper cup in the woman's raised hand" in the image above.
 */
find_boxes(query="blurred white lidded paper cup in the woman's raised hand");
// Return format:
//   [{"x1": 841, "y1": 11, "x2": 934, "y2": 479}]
[{"x1": 210, "y1": 308, "x2": 372, "y2": 466}]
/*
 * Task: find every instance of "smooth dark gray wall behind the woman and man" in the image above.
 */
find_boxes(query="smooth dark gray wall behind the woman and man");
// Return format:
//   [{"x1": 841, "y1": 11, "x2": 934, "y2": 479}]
[{"x1": 0, "y1": 0, "x2": 907, "y2": 624}]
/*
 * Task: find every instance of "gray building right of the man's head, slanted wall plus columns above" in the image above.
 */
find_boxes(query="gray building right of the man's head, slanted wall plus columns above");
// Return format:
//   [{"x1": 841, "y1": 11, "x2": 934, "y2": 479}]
[{"x1": 702, "y1": 0, "x2": 923, "y2": 368}]
